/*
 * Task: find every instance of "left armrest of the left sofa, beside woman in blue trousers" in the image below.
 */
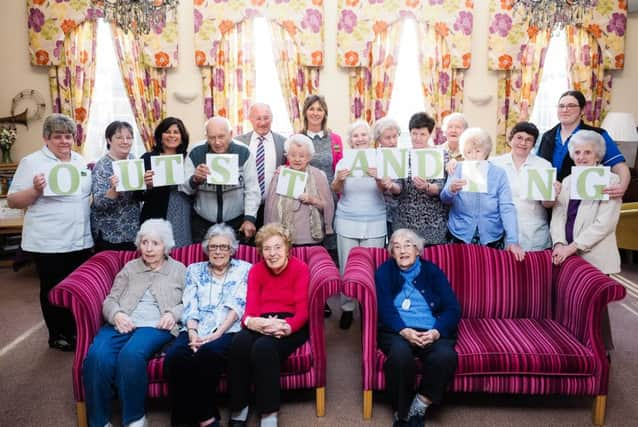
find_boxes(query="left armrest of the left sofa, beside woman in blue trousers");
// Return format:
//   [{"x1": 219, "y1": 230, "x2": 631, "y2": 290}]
[{"x1": 49, "y1": 251, "x2": 124, "y2": 401}]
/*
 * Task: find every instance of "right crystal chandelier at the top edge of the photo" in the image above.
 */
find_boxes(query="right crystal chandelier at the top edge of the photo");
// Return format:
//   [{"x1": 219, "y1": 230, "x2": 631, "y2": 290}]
[{"x1": 512, "y1": 0, "x2": 598, "y2": 30}]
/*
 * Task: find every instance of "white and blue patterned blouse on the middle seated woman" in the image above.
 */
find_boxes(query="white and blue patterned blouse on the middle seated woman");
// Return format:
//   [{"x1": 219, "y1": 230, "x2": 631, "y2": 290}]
[{"x1": 182, "y1": 259, "x2": 252, "y2": 336}]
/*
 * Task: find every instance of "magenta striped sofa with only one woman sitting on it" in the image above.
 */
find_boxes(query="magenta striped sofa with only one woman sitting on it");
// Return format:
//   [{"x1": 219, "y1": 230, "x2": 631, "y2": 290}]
[{"x1": 343, "y1": 244, "x2": 625, "y2": 425}]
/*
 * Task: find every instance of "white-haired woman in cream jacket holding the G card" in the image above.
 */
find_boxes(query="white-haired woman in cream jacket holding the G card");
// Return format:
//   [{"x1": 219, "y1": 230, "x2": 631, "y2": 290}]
[{"x1": 549, "y1": 130, "x2": 622, "y2": 350}]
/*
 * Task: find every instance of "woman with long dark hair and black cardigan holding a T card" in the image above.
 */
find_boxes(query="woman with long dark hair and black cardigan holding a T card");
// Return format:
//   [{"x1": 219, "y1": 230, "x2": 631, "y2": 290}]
[{"x1": 140, "y1": 117, "x2": 193, "y2": 247}]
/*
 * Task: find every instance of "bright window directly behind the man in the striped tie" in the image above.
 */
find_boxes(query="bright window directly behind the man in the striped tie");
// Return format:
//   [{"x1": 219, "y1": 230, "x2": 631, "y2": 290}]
[{"x1": 253, "y1": 17, "x2": 293, "y2": 136}]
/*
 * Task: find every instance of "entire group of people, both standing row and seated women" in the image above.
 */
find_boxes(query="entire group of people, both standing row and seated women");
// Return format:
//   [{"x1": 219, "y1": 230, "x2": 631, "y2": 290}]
[{"x1": 8, "y1": 91, "x2": 629, "y2": 426}]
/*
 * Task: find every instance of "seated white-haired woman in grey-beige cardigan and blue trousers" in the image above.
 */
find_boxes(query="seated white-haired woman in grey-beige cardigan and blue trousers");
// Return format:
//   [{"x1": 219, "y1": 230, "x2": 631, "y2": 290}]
[{"x1": 83, "y1": 219, "x2": 186, "y2": 427}]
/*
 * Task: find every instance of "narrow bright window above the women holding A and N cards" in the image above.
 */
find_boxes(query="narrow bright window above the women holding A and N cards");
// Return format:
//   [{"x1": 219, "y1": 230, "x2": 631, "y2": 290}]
[{"x1": 388, "y1": 19, "x2": 425, "y2": 147}]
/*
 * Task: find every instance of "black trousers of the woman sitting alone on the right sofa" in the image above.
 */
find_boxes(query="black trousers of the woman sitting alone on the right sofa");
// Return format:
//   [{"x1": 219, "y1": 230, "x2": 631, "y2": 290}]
[{"x1": 378, "y1": 331, "x2": 458, "y2": 419}]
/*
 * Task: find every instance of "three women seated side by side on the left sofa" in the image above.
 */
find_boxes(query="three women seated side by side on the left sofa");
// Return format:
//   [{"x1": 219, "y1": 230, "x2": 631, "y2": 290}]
[{"x1": 82, "y1": 219, "x2": 310, "y2": 427}]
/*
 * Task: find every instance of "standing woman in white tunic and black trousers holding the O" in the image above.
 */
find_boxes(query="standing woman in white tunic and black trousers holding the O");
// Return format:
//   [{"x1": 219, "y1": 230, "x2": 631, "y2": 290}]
[{"x1": 7, "y1": 114, "x2": 93, "y2": 351}]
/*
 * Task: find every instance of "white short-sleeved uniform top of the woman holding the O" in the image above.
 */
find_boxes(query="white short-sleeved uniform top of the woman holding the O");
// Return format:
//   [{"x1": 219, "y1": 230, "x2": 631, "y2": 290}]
[{"x1": 9, "y1": 146, "x2": 93, "y2": 253}]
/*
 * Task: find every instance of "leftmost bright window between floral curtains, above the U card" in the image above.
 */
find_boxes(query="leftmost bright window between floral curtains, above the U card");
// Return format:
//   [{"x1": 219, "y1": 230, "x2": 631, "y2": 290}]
[{"x1": 83, "y1": 19, "x2": 146, "y2": 162}]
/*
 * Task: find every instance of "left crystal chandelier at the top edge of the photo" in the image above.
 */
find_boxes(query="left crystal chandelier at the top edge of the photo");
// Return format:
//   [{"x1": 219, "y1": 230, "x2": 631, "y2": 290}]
[{"x1": 92, "y1": 0, "x2": 179, "y2": 34}]
